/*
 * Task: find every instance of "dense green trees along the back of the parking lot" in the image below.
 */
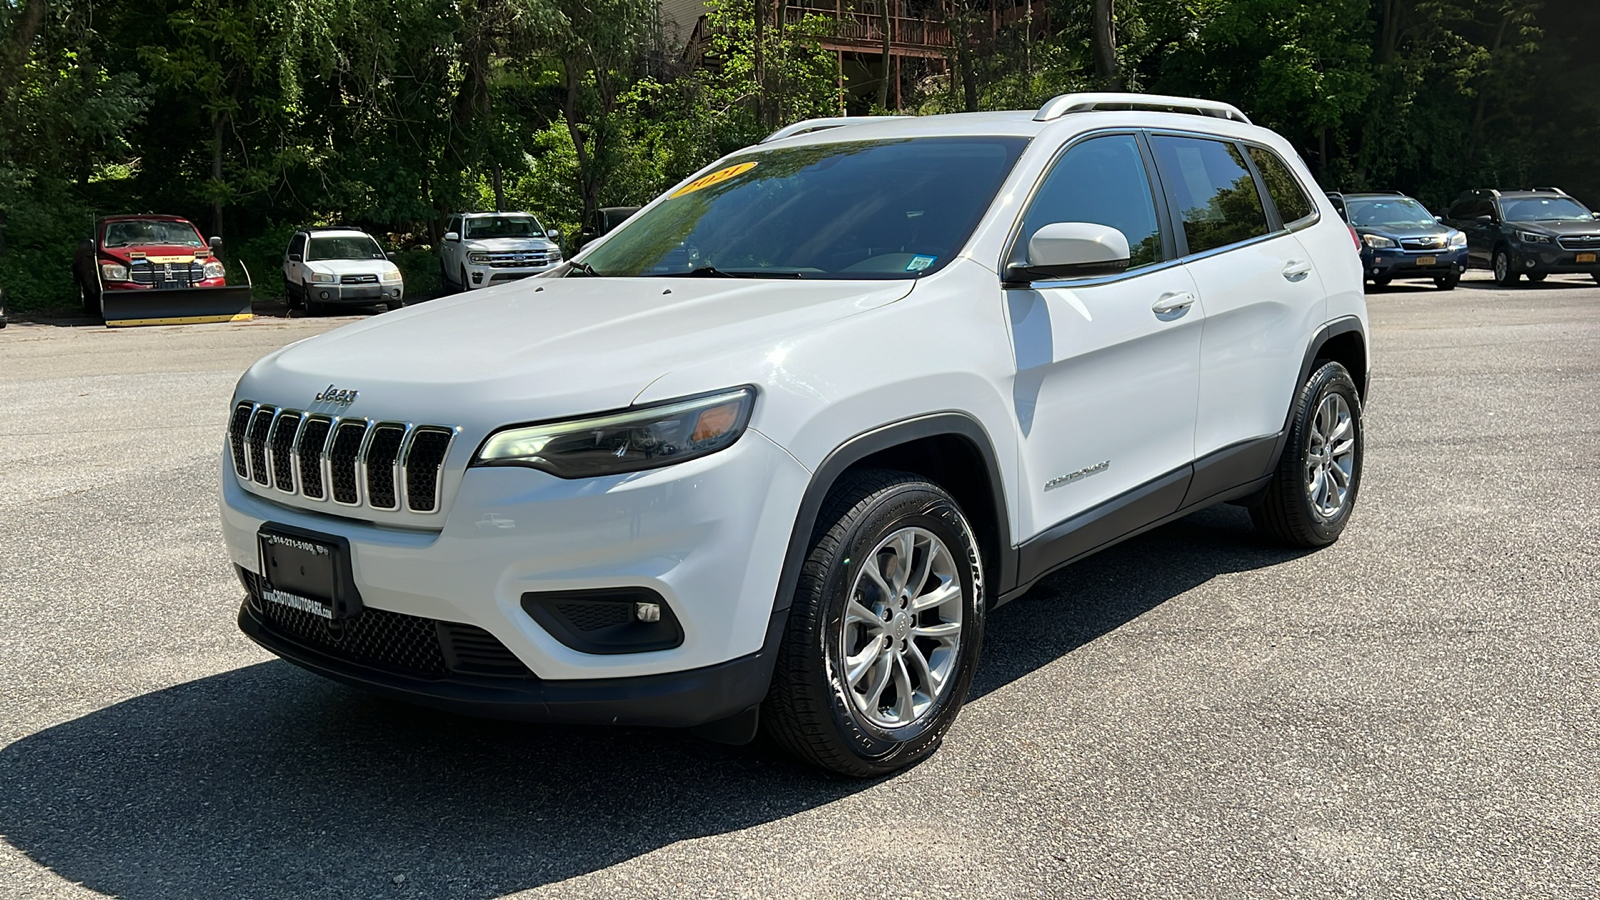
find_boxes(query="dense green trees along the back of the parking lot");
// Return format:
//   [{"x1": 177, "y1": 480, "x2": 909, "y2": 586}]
[{"x1": 0, "y1": 0, "x2": 1600, "y2": 306}]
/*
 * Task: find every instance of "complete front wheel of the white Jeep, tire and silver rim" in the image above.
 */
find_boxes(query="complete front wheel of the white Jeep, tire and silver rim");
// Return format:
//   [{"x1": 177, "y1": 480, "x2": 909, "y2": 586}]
[{"x1": 762, "y1": 471, "x2": 984, "y2": 778}]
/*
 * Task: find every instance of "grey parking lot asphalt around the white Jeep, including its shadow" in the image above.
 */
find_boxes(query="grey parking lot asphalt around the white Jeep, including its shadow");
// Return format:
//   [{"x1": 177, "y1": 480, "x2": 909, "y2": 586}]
[{"x1": 0, "y1": 277, "x2": 1600, "y2": 900}]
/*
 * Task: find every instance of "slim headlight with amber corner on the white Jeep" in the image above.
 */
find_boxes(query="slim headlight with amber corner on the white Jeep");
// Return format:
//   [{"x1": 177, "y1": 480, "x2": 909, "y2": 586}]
[{"x1": 474, "y1": 388, "x2": 755, "y2": 479}]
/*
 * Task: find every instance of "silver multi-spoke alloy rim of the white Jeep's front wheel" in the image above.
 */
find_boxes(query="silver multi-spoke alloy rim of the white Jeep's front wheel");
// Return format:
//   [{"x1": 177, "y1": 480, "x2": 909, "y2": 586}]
[{"x1": 840, "y1": 527, "x2": 963, "y2": 729}]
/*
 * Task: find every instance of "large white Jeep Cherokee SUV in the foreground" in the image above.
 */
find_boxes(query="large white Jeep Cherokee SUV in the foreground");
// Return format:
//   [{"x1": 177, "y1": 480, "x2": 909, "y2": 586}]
[{"x1": 222, "y1": 94, "x2": 1368, "y2": 775}]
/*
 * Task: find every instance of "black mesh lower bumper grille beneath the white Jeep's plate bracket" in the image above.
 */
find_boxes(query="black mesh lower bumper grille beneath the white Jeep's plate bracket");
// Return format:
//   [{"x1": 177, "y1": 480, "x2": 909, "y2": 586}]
[{"x1": 243, "y1": 572, "x2": 534, "y2": 679}]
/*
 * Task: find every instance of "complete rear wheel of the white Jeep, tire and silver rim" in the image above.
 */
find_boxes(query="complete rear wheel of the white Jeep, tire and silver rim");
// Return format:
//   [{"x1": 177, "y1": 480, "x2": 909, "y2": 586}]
[{"x1": 1250, "y1": 362, "x2": 1365, "y2": 548}]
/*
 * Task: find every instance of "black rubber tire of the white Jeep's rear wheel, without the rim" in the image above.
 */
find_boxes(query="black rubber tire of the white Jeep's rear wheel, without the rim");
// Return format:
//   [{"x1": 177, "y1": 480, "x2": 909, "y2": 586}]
[{"x1": 1250, "y1": 362, "x2": 1365, "y2": 548}]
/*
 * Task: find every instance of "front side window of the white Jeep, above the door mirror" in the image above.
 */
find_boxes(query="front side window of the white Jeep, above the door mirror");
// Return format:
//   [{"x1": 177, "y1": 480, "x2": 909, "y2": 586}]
[{"x1": 1018, "y1": 135, "x2": 1166, "y2": 269}]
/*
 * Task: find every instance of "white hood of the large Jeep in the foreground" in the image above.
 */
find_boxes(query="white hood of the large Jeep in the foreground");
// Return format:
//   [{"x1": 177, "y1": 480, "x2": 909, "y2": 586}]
[{"x1": 238, "y1": 277, "x2": 915, "y2": 431}]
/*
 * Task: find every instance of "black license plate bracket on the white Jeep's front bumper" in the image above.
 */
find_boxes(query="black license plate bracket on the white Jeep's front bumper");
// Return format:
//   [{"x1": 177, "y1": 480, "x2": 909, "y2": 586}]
[{"x1": 256, "y1": 522, "x2": 363, "y2": 621}]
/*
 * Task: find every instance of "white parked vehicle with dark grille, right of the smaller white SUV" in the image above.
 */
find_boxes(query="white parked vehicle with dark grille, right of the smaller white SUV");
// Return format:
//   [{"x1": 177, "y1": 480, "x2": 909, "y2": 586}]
[{"x1": 438, "y1": 213, "x2": 562, "y2": 290}]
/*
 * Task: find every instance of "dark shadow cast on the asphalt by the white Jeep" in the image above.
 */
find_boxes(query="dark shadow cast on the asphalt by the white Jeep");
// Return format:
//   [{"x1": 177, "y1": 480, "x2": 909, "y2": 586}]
[{"x1": 0, "y1": 509, "x2": 1294, "y2": 900}]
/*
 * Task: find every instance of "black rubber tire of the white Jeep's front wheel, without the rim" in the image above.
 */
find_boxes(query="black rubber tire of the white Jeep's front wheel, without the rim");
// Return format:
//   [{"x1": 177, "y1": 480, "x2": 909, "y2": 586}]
[{"x1": 762, "y1": 469, "x2": 986, "y2": 778}]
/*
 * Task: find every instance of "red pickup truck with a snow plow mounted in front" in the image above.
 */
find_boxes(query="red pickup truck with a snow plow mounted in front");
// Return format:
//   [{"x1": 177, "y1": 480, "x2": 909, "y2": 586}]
[{"x1": 72, "y1": 215, "x2": 250, "y2": 325}]
